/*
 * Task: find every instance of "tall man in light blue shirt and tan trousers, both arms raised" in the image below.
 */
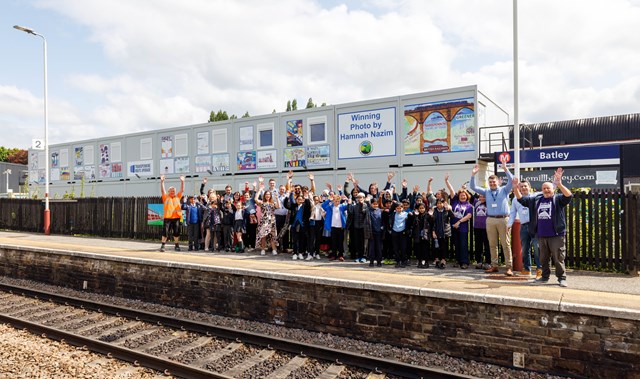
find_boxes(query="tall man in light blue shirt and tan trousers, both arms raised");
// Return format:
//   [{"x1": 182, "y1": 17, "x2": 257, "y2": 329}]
[{"x1": 469, "y1": 161, "x2": 513, "y2": 276}]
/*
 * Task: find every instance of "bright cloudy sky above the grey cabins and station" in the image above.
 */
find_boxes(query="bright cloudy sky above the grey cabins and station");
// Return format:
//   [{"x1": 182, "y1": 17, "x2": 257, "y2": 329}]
[{"x1": 0, "y1": 0, "x2": 640, "y2": 148}]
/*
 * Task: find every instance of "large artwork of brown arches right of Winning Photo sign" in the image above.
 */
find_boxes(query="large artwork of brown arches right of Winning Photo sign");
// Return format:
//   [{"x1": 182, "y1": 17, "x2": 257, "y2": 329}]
[{"x1": 403, "y1": 97, "x2": 476, "y2": 155}]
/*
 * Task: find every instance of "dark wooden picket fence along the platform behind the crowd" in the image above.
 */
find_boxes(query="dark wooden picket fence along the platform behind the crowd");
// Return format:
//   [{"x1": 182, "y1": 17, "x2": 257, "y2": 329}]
[{"x1": 0, "y1": 191, "x2": 640, "y2": 275}]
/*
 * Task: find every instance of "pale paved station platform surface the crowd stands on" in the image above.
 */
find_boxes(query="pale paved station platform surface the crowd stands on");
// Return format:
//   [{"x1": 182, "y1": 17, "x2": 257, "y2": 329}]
[{"x1": 0, "y1": 231, "x2": 640, "y2": 321}]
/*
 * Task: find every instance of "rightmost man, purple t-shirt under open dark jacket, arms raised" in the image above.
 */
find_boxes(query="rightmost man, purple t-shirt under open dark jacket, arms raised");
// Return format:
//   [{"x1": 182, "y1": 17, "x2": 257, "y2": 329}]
[{"x1": 512, "y1": 168, "x2": 572, "y2": 287}]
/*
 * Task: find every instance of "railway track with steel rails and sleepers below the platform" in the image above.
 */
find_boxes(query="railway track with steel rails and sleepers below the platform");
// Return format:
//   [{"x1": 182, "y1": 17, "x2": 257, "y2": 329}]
[{"x1": 0, "y1": 284, "x2": 471, "y2": 379}]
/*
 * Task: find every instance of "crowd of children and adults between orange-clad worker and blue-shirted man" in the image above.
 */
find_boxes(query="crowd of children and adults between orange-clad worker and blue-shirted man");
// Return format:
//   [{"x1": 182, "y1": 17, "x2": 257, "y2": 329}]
[{"x1": 170, "y1": 171, "x2": 490, "y2": 269}]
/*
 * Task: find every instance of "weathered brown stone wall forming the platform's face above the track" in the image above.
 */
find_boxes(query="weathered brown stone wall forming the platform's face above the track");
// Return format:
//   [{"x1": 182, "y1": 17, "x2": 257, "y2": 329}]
[{"x1": 0, "y1": 248, "x2": 640, "y2": 378}]
